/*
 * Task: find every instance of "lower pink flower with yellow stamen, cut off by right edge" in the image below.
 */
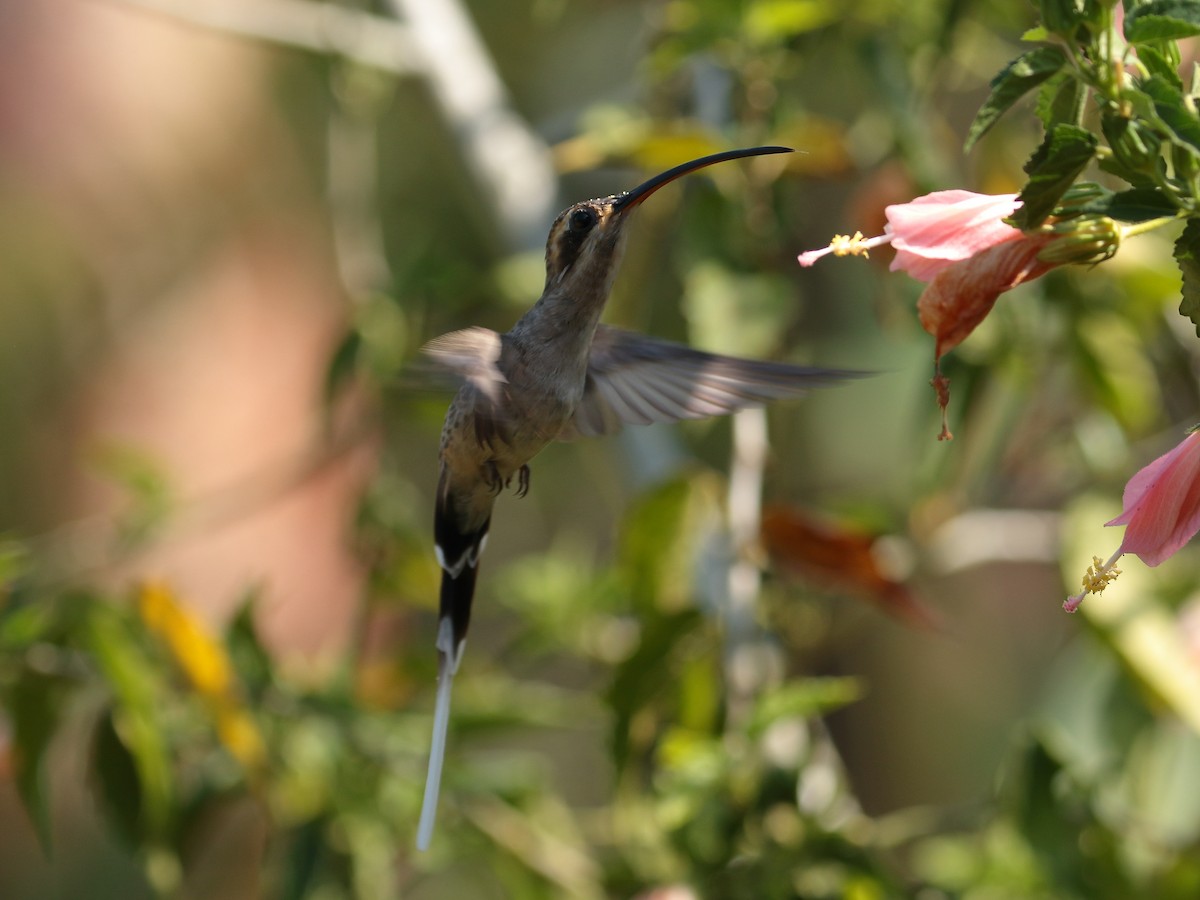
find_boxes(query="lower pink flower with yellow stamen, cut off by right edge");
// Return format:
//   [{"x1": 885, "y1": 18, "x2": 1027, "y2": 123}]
[{"x1": 1062, "y1": 428, "x2": 1200, "y2": 612}]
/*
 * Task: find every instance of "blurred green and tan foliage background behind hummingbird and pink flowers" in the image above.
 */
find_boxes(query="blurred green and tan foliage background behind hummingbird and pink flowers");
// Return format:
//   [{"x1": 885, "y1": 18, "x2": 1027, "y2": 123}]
[{"x1": 0, "y1": 0, "x2": 1200, "y2": 900}]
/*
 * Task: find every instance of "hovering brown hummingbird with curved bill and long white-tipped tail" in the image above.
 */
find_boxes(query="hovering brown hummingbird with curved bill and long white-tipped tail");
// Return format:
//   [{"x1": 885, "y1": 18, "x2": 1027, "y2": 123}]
[{"x1": 416, "y1": 146, "x2": 860, "y2": 850}]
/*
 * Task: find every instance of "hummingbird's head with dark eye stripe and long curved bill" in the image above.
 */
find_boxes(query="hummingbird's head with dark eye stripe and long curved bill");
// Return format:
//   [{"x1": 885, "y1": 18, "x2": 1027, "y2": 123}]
[{"x1": 546, "y1": 146, "x2": 791, "y2": 296}]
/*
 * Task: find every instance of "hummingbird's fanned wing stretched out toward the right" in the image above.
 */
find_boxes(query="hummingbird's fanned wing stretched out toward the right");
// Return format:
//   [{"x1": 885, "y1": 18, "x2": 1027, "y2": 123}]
[{"x1": 559, "y1": 325, "x2": 866, "y2": 440}]
